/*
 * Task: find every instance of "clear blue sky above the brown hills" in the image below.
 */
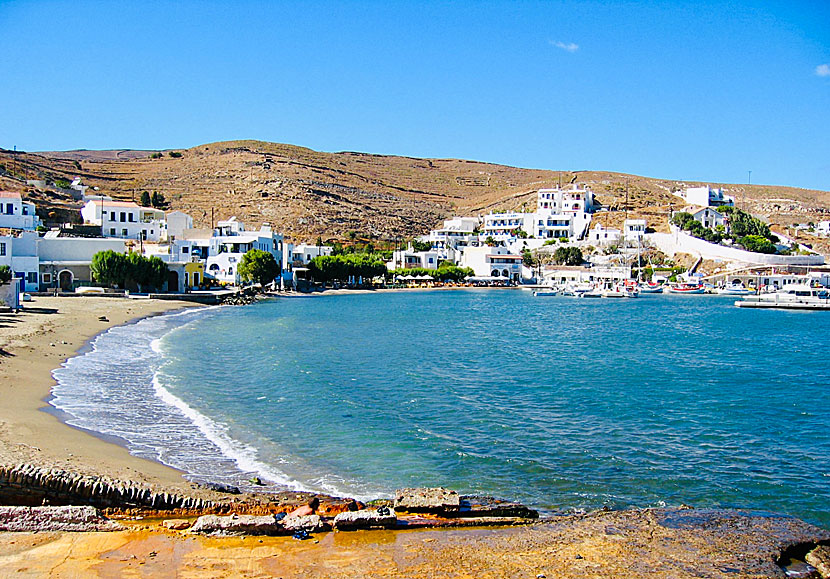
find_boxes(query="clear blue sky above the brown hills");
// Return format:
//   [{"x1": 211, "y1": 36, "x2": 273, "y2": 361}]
[{"x1": 0, "y1": 0, "x2": 830, "y2": 190}]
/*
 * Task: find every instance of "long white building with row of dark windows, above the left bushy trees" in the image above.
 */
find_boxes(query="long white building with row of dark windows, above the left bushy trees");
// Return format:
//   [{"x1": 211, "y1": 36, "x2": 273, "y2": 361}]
[{"x1": 81, "y1": 195, "x2": 167, "y2": 241}]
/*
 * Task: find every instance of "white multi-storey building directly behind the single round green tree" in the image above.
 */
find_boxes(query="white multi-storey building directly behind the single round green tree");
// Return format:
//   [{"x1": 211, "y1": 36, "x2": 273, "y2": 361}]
[{"x1": 205, "y1": 217, "x2": 283, "y2": 285}]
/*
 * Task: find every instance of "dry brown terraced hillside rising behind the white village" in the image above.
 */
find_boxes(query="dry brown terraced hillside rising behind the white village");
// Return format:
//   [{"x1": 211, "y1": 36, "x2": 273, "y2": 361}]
[{"x1": 0, "y1": 141, "x2": 830, "y2": 245}]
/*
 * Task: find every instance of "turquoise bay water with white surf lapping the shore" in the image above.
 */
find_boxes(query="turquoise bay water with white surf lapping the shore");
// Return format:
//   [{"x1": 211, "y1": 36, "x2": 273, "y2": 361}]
[{"x1": 53, "y1": 290, "x2": 830, "y2": 526}]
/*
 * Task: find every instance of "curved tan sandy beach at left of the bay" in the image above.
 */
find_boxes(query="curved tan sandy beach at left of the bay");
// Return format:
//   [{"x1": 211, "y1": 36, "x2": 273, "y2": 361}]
[{"x1": 0, "y1": 296, "x2": 197, "y2": 489}]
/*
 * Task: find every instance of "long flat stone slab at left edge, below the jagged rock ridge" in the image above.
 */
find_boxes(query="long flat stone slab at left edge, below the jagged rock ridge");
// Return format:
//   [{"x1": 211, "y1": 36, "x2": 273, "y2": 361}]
[{"x1": 0, "y1": 507, "x2": 123, "y2": 532}]
